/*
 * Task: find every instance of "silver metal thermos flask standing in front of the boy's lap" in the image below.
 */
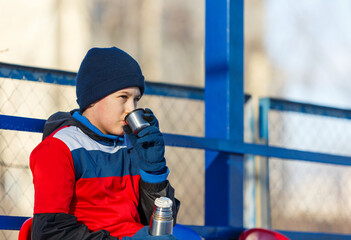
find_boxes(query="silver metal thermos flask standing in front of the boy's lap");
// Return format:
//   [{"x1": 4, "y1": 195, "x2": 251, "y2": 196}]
[{"x1": 149, "y1": 197, "x2": 173, "y2": 236}]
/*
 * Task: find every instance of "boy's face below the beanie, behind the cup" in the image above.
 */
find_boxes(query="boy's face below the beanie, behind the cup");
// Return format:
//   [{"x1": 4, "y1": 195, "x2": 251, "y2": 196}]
[{"x1": 83, "y1": 87, "x2": 141, "y2": 135}]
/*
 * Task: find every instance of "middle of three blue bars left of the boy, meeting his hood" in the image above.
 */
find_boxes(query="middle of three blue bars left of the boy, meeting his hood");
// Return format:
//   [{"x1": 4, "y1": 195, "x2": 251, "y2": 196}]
[{"x1": 0, "y1": 115, "x2": 45, "y2": 132}]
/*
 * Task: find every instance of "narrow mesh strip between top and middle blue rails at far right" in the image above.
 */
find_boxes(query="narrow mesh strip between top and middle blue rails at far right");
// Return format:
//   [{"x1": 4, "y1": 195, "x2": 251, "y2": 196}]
[{"x1": 269, "y1": 111, "x2": 351, "y2": 155}]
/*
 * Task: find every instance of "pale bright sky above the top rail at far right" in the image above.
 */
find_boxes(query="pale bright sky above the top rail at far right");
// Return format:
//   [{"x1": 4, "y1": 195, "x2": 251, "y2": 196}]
[{"x1": 264, "y1": 0, "x2": 351, "y2": 108}]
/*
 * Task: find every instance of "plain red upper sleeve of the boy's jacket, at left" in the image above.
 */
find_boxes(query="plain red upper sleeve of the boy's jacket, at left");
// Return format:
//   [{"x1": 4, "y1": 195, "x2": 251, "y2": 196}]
[{"x1": 30, "y1": 137, "x2": 75, "y2": 214}]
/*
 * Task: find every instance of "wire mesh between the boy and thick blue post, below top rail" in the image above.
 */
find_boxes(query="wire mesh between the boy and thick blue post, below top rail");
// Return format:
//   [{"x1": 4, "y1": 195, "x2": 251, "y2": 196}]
[{"x1": 138, "y1": 96, "x2": 204, "y2": 225}]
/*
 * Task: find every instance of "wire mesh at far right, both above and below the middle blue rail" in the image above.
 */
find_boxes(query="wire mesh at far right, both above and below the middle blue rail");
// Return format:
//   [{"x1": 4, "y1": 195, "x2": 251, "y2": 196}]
[{"x1": 269, "y1": 111, "x2": 351, "y2": 233}]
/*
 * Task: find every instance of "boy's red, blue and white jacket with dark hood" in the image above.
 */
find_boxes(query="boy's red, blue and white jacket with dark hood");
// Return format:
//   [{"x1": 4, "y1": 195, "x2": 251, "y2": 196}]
[{"x1": 30, "y1": 112, "x2": 179, "y2": 239}]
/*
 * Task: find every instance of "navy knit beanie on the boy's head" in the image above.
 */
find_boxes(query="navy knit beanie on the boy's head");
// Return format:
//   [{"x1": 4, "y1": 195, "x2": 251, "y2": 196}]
[{"x1": 76, "y1": 47, "x2": 145, "y2": 112}]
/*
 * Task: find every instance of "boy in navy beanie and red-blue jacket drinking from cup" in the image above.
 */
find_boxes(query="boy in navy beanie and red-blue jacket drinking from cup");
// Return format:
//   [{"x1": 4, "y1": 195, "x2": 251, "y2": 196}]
[{"x1": 30, "y1": 47, "x2": 180, "y2": 239}]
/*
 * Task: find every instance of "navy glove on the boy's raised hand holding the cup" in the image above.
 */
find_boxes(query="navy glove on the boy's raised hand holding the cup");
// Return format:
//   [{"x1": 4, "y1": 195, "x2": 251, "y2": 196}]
[{"x1": 123, "y1": 109, "x2": 166, "y2": 173}]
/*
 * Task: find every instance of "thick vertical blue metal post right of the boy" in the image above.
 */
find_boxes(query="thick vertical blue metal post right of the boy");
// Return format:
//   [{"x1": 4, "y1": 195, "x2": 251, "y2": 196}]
[{"x1": 205, "y1": 0, "x2": 244, "y2": 227}]
